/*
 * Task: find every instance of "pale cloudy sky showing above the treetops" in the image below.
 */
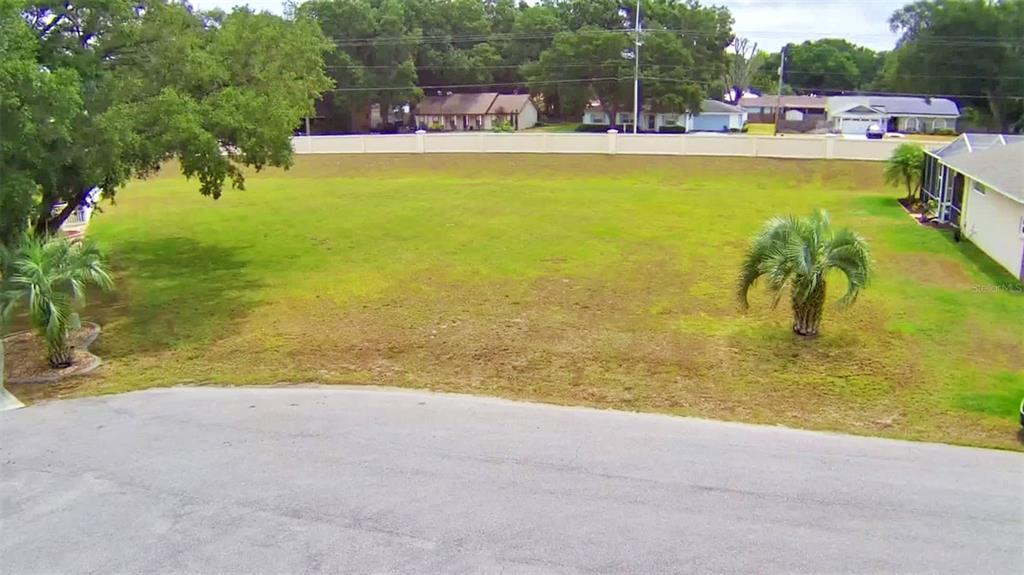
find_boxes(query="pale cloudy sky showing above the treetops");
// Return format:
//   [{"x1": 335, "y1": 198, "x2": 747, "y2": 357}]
[{"x1": 191, "y1": 0, "x2": 909, "y2": 51}]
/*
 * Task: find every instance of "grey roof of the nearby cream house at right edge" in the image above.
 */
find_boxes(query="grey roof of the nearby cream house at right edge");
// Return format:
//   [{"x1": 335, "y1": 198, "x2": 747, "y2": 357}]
[{"x1": 932, "y1": 134, "x2": 1024, "y2": 204}]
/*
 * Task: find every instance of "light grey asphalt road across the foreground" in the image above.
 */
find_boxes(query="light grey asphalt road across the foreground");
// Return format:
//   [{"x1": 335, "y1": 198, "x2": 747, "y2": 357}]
[{"x1": 0, "y1": 388, "x2": 1024, "y2": 575}]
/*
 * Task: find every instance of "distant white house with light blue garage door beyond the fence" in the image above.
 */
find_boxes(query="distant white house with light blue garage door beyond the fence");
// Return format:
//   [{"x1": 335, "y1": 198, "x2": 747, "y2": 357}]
[{"x1": 583, "y1": 100, "x2": 746, "y2": 132}]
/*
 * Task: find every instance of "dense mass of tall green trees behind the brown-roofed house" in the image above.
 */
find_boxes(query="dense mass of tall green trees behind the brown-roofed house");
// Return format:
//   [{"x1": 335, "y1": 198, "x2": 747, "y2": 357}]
[{"x1": 298, "y1": 0, "x2": 732, "y2": 124}]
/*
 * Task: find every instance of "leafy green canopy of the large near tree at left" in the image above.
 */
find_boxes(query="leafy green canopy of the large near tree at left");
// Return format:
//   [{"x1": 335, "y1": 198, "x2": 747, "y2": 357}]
[{"x1": 0, "y1": 0, "x2": 330, "y2": 237}]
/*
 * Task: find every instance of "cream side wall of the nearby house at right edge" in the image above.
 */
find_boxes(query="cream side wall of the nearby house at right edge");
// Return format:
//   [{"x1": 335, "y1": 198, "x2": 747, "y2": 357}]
[{"x1": 962, "y1": 178, "x2": 1024, "y2": 278}]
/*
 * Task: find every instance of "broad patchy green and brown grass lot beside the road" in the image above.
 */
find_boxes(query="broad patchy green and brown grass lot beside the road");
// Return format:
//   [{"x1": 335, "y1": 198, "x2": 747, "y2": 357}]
[{"x1": 9, "y1": 154, "x2": 1024, "y2": 447}]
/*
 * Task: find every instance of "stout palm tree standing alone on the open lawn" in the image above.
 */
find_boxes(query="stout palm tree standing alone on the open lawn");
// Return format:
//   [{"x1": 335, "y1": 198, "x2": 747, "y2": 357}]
[{"x1": 737, "y1": 210, "x2": 871, "y2": 336}]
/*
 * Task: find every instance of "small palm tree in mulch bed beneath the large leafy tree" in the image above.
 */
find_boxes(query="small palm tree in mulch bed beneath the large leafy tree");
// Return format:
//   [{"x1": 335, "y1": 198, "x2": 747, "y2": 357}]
[{"x1": 0, "y1": 235, "x2": 113, "y2": 367}]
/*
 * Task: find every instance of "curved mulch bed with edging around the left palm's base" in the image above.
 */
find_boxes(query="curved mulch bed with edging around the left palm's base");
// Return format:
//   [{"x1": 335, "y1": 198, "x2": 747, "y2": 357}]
[{"x1": 3, "y1": 322, "x2": 102, "y2": 385}]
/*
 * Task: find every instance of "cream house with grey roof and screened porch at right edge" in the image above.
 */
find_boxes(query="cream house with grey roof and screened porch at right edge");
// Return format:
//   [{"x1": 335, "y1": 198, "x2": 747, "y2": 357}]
[{"x1": 922, "y1": 134, "x2": 1024, "y2": 280}]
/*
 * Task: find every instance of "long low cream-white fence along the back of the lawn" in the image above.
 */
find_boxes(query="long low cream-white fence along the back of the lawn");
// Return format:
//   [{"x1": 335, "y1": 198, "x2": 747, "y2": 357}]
[{"x1": 292, "y1": 132, "x2": 934, "y2": 162}]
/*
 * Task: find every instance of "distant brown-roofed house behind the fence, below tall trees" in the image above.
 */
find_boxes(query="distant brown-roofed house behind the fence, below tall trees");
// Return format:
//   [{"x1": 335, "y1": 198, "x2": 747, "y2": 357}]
[{"x1": 414, "y1": 92, "x2": 539, "y2": 132}]
